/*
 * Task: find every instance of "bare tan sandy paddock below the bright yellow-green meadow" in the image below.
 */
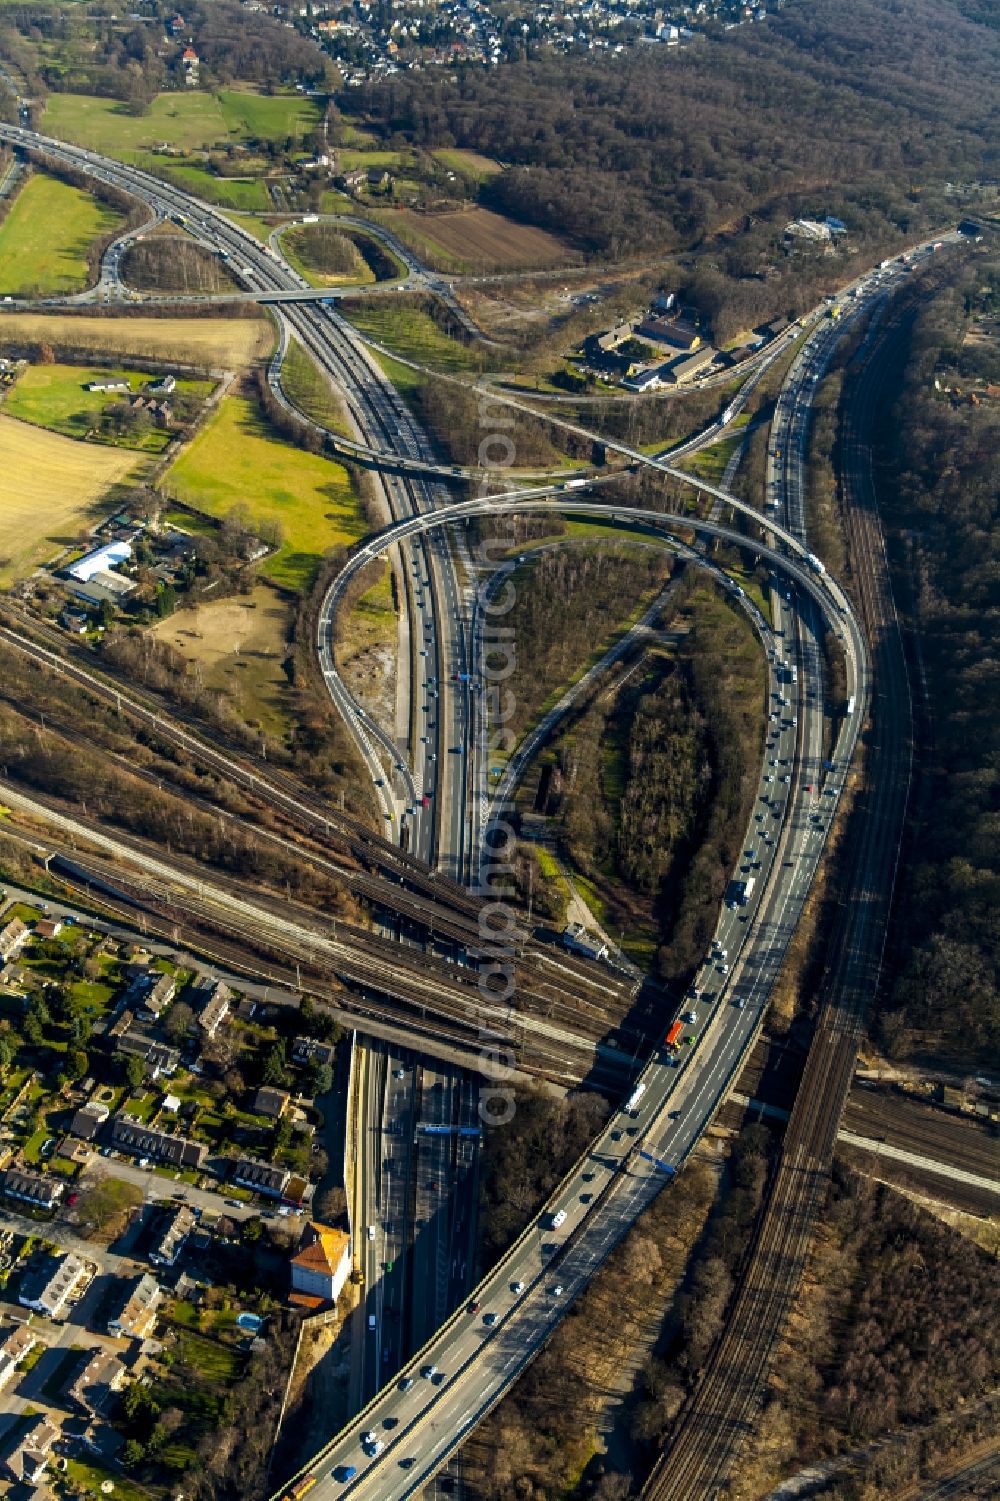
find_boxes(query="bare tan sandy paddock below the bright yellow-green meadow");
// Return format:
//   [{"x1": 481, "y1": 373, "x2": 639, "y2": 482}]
[{"x1": 153, "y1": 576, "x2": 291, "y2": 738}]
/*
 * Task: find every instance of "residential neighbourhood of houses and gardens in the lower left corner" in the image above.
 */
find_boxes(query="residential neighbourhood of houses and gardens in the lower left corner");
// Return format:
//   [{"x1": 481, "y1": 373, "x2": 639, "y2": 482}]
[{"x1": 0, "y1": 893, "x2": 357, "y2": 1496}]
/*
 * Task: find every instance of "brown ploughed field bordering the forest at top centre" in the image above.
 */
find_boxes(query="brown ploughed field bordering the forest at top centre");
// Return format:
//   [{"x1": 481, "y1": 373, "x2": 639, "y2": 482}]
[{"x1": 384, "y1": 209, "x2": 580, "y2": 273}]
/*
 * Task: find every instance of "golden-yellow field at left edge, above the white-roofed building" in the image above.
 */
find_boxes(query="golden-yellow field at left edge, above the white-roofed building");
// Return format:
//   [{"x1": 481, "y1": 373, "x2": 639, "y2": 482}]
[{"x1": 0, "y1": 416, "x2": 137, "y2": 587}]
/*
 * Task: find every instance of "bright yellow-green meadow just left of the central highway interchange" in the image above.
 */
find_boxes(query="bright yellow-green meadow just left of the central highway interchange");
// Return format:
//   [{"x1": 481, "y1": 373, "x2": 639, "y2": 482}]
[{"x1": 162, "y1": 396, "x2": 365, "y2": 590}]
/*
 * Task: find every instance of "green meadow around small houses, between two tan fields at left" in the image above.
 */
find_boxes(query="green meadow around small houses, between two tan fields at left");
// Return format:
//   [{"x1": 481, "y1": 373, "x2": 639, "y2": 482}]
[{"x1": 3, "y1": 365, "x2": 212, "y2": 453}]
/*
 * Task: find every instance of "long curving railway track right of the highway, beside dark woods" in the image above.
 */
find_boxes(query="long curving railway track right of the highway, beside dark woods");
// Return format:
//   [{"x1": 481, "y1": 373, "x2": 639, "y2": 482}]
[{"x1": 643, "y1": 286, "x2": 911, "y2": 1501}]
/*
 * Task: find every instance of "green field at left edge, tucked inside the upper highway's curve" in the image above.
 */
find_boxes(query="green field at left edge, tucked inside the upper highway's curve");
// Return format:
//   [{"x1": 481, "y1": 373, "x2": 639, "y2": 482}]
[{"x1": 0, "y1": 176, "x2": 123, "y2": 294}]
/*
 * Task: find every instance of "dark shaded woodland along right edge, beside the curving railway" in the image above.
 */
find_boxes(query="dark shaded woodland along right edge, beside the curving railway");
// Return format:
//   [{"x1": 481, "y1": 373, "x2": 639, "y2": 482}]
[{"x1": 878, "y1": 254, "x2": 1000, "y2": 1064}]
